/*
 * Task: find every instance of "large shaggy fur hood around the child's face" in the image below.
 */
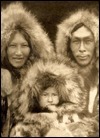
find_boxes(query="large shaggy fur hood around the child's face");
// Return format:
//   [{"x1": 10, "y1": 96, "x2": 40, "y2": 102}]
[{"x1": 16, "y1": 60, "x2": 86, "y2": 115}]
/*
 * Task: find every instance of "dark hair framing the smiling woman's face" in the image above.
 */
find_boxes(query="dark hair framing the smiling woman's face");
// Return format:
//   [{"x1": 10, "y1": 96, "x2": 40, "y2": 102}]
[{"x1": 1, "y1": 26, "x2": 39, "y2": 81}]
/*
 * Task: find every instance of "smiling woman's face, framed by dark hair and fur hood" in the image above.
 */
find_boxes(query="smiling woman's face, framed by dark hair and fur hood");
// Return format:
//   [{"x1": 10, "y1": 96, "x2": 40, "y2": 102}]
[{"x1": 7, "y1": 32, "x2": 30, "y2": 68}]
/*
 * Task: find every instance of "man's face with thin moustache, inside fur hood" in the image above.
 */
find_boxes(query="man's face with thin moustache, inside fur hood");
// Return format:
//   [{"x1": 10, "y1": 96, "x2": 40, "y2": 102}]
[{"x1": 71, "y1": 26, "x2": 95, "y2": 66}]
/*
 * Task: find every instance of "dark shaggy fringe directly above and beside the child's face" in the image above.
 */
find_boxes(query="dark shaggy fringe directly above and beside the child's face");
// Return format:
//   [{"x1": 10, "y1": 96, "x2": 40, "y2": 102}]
[{"x1": 34, "y1": 72, "x2": 67, "y2": 103}]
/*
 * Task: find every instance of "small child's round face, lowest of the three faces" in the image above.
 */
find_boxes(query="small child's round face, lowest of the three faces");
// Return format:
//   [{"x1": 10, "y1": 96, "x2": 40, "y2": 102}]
[{"x1": 39, "y1": 87, "x2": 59, "y2": 108}]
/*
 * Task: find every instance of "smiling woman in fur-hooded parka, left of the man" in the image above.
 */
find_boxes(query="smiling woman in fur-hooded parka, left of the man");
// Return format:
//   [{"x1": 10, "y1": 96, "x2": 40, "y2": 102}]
[{"x1": 1, "y1": 2, "x2": 54, "y2": 137}]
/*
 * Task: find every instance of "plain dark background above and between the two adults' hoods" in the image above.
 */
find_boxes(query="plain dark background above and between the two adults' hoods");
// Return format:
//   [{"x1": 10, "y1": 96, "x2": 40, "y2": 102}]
[{"x1": 1, "y1": 1, "x2": 99, "y2": 43}]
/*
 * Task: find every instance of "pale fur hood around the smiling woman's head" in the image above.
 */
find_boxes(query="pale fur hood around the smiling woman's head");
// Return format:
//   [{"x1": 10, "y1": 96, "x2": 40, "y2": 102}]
[{"x1": 1, "y1": 2, "x2": 54, "y2": 64}]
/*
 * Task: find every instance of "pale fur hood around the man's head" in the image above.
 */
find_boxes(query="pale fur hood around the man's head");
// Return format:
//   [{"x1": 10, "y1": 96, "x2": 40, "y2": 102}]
[{"x1": 55, "y1": 9, "x2": 99, "y2": 67}]
